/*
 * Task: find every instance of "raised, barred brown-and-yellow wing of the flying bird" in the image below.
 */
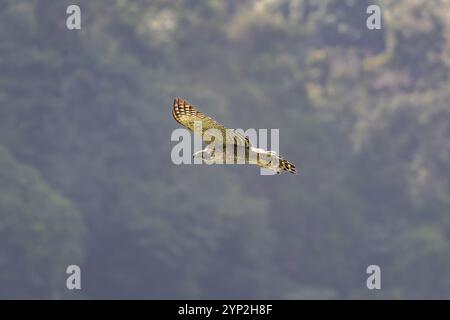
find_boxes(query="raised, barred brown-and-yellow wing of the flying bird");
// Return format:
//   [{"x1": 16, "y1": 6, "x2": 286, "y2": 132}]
[{"x1": 172, "y1": 98, "x2": 250, "y2": 148}]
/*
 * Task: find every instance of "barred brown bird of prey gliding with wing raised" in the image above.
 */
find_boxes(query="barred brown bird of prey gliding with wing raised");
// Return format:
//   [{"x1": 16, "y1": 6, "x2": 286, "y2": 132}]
[{"x1": 172, "y1": 98, "x2": 297, "y2": 174}]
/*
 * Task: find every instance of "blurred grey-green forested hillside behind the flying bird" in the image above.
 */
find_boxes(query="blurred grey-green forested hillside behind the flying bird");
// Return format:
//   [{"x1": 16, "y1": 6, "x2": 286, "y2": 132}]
[{"x1": 0, "y1": 0, "x2": 450, "y2": 299}]
